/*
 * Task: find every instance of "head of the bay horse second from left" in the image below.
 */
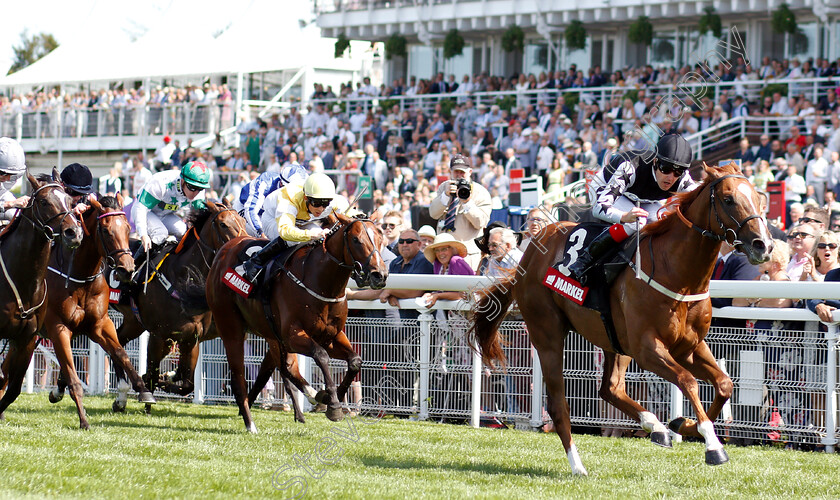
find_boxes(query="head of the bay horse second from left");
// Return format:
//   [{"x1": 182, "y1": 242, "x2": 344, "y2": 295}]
[{"x1": 90, "y1": 193, "x2": 134, "y2": 283}]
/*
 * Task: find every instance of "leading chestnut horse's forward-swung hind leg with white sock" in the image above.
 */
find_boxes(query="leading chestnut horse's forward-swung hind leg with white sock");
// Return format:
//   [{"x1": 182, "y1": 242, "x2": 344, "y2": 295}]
[{"x1": 598, "y1": 351, "x2": 671, "y2": 448}]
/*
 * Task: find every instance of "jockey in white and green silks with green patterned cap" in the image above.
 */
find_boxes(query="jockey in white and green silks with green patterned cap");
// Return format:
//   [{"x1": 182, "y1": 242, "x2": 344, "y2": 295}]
[{"x1": 132, "y1": 161, "x2": 210, "y2": 252}]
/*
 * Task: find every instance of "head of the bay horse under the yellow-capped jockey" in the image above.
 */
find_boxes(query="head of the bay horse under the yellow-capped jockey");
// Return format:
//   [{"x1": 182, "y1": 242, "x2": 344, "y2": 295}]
[{"x1": 335, "y1": 213, "x2": 388, "y2": 290}]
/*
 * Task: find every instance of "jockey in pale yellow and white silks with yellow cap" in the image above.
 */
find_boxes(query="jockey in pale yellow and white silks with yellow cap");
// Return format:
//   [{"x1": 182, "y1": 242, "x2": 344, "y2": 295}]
[{"x1": 243, "y1": 173, "x2": 347, "y2": 282}]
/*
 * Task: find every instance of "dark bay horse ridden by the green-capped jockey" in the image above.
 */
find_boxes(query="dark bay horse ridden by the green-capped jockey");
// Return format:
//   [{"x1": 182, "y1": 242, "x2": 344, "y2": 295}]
[{"x1": 113, "y1": 202, "x2": 245, "y2": 411}]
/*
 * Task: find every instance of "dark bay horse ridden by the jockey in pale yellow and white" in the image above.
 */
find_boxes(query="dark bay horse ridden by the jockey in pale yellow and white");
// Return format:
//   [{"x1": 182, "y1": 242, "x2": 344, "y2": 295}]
[{"x1": 199, "y1": 214, "x2": 388, "y2": 433}]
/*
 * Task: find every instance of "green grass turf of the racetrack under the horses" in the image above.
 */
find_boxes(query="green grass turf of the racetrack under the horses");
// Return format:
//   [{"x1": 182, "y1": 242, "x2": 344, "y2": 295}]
[{"x1": 0, "y1": 394, "x2": 840, "y2": 500}]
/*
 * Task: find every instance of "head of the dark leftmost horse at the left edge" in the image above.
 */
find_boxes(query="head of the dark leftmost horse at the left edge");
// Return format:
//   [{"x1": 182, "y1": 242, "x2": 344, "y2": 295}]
[{"x1": 26, "y1": 168, "x2": 83, "y2": 250}]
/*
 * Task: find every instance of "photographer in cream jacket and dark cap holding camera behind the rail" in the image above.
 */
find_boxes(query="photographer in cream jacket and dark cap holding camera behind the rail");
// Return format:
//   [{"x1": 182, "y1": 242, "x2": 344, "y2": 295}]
[{"x1": 429, "y1": 154, "x2": 491, "y2": 269}]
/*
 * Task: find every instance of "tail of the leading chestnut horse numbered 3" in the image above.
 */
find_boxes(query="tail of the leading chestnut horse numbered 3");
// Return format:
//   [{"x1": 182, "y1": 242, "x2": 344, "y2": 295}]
[{"x1": 467, "y1": 277, "x2": 515, "y2": 366}]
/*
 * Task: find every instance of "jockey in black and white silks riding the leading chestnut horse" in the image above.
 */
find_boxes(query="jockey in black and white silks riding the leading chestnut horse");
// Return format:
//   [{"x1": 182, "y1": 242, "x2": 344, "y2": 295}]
[{"x1": 555, "y1": 134, "x2": 697, "y2": 281}]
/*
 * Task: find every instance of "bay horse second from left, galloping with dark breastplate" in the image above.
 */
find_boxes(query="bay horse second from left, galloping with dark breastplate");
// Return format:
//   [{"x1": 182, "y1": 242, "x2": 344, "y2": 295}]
[{"x1": 44, "y1": 194, "x2": 155, "y2": 429}]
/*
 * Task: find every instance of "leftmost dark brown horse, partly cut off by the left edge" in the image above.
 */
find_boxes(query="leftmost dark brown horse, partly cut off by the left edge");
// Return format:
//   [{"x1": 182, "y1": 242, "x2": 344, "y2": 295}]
[{"x1": 0, "y1": 172, "x2": 82, "y2": 419}]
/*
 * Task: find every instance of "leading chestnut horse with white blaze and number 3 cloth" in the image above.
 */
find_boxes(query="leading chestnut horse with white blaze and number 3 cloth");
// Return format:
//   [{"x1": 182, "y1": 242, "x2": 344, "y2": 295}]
[{"x1": 470, "y1": 165, "x2": 773, "y2": 475}]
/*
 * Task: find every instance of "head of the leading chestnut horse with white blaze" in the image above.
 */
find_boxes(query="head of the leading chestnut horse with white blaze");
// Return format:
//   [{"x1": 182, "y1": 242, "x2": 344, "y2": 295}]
[{"x1": 703, "y1": 162, "x2": 773, "y2": 264}]
